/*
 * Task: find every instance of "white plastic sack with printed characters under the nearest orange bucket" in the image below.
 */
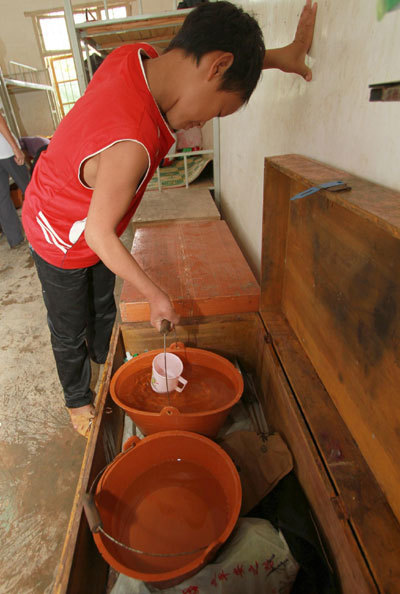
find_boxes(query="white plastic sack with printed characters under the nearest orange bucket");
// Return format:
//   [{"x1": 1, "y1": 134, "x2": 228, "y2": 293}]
[{"x1": 111, "y1": 518, "x2": 299, "y2": 594}]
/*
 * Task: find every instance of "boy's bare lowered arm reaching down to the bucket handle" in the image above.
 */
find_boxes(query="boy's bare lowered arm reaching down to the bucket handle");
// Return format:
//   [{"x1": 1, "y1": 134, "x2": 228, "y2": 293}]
[{"x1": 85, "y1": 142, "x2": 179, "y2": 330}]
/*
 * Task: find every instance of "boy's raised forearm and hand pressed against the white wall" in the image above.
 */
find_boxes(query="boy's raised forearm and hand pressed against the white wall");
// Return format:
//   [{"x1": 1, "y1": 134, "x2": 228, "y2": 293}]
[{"x1": 263, "y1": 0, "x2": 317, "y2": 81}]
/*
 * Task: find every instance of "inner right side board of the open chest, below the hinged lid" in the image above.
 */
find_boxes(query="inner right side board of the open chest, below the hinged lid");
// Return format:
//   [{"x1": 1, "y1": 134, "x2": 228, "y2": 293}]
[{"x1": 259, "y1": 330, "x2": 377, "y2": 594}]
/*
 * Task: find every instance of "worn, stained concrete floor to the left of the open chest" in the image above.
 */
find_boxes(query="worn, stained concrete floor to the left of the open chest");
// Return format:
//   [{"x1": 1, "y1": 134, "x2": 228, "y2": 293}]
[{"x1": 0, "y1": 214, "x2": 132, "y2": 594}]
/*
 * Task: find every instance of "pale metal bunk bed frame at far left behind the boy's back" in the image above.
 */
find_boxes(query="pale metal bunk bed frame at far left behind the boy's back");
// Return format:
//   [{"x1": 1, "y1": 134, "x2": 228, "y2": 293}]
[{"x1": 0, "y1": 60, "x2": 62, "y2": 138}]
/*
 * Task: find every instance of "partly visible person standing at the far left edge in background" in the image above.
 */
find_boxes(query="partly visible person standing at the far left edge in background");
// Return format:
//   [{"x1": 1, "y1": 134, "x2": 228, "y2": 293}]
[{"x1": 0, "y1": 114, "x2": 29, "y2": 248}]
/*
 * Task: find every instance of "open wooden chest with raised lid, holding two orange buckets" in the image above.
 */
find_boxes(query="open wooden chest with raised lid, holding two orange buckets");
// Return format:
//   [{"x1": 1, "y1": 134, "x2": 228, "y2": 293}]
[{"x1": 54, "y1": 155, "x2": 400, "y2": 594}]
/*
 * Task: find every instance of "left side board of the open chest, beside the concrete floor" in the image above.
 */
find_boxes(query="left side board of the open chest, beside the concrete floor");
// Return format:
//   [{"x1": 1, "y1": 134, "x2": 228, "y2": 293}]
[{"x1": 52, "y1": 325, "x2": 125, "y2": 594}]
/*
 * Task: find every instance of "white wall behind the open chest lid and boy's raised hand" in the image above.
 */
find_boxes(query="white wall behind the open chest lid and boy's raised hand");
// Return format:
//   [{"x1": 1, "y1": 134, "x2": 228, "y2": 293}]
[{"x1": 221, "y1": 0, "x2": 400, "y2": 276}]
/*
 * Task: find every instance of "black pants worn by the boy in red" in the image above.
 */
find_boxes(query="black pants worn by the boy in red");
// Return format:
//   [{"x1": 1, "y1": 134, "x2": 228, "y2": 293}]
[{"x1": 32, "y1": 252, "x2": 116, "y2": 408}]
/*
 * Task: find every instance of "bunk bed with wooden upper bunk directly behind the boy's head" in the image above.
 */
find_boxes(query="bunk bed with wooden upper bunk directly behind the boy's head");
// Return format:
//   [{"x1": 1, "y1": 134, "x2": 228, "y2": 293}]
[{"x1": 64, "y1": 0, "x2": 220, "y2": 206}]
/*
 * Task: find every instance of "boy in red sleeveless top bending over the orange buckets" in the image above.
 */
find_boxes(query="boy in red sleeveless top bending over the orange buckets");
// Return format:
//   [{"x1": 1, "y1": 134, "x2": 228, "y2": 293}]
[{"x1": 23, "y1": 0, "x2": 316, "y2": 435}]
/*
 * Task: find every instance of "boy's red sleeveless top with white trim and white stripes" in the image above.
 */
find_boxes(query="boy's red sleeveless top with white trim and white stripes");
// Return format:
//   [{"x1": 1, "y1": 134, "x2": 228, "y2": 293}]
[{"x1": 22, "y1": 43, "x2": 174, "y2": 268}]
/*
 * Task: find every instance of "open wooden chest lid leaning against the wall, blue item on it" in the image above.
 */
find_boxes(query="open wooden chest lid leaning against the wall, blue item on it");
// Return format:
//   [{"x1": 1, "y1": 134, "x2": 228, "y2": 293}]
[{"x1": 261, "y1": 155, "x2": 400, "y2": 592}]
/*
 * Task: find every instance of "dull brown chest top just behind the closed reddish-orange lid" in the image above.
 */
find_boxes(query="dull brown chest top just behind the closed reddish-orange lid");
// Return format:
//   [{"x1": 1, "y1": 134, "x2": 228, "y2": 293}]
[{"x1": 132, "y1": 188, "x2": 221, "y2": 229}]
